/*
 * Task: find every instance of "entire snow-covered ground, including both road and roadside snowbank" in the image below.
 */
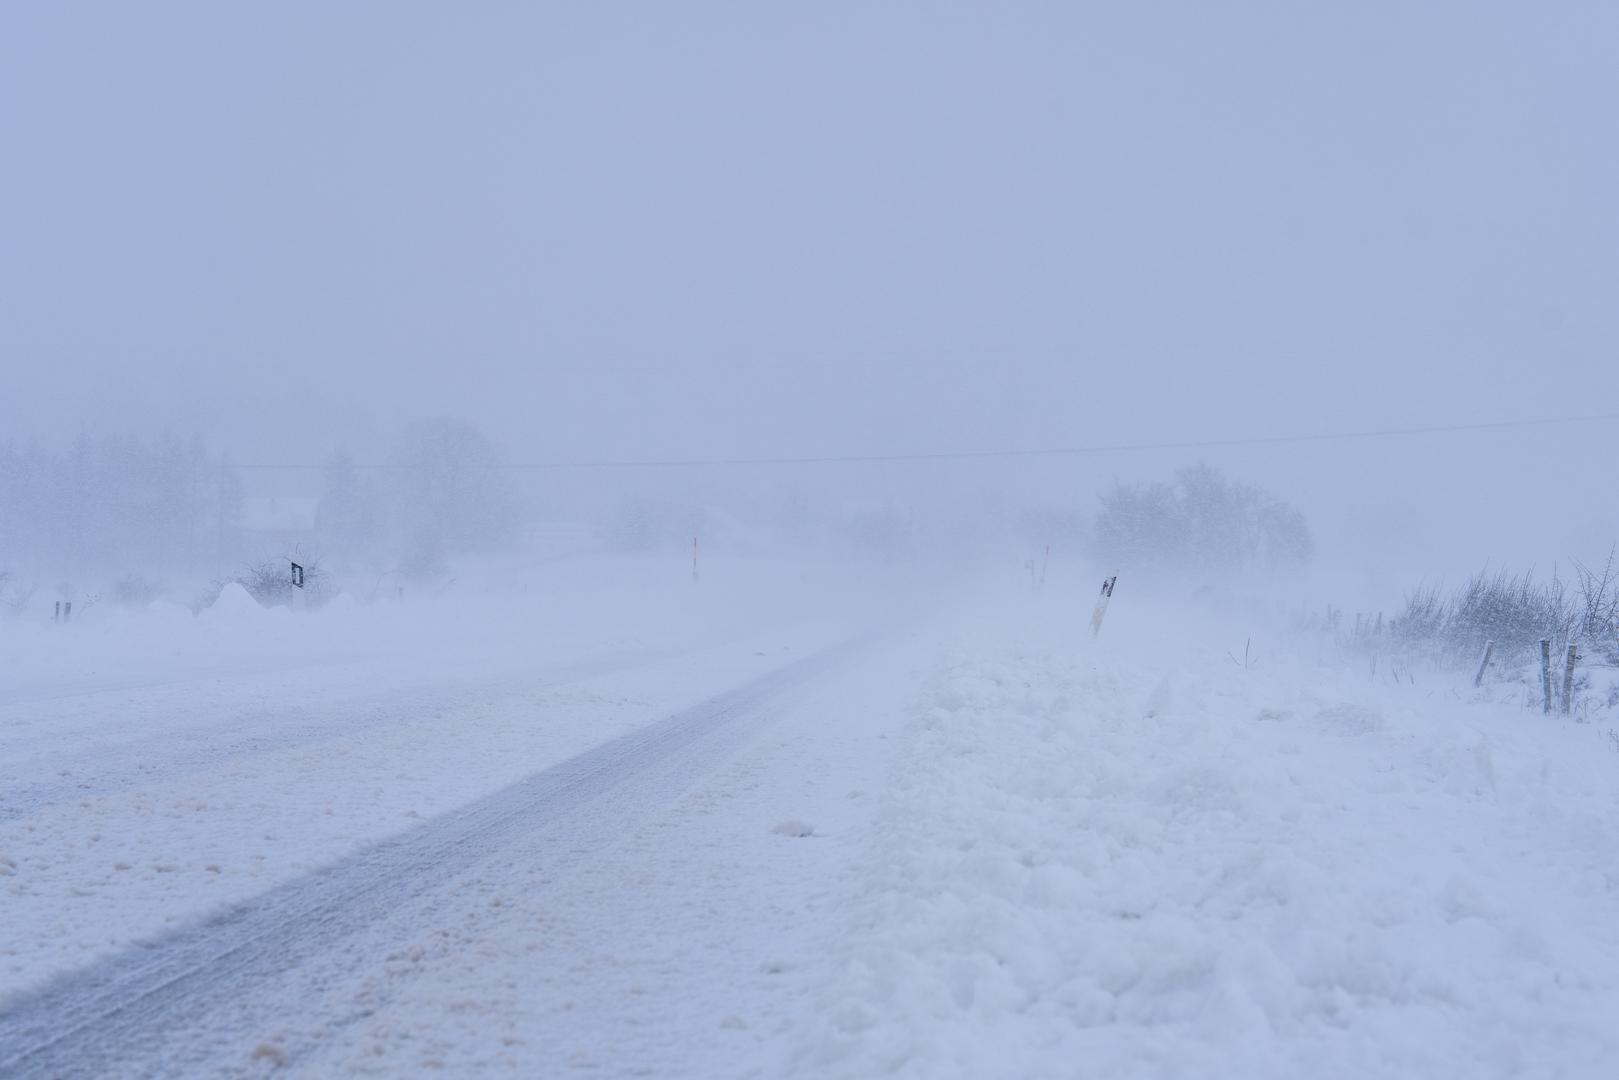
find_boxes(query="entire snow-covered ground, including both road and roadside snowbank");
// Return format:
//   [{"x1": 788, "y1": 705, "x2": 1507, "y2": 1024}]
[{"x1": 0, "y1": 560, "x2": 1619, "y2": 1077}]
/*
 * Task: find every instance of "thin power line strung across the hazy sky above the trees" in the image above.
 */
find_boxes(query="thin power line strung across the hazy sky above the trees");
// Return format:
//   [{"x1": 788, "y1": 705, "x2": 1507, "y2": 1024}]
[{"x1": 236, "y1": 413, "x2": 1619, "y2": 471}]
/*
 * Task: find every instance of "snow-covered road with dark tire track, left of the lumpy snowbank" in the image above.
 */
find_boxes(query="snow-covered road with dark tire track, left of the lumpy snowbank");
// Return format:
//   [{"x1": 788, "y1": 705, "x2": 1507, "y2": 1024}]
[{"x1": 0, "y1": 565, "x2": 939, "y2": 1077}]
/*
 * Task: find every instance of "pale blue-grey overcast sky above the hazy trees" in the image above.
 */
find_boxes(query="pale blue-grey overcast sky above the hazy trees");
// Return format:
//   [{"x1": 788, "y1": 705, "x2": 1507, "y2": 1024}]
[{"x1": 0, "y1": 0, "x2": 1619, "y2": 582}]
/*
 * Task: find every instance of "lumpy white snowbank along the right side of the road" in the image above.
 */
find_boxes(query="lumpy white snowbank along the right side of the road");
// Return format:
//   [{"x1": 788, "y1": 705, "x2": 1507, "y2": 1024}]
[{"x1": 801, "y1": 602, "x2": 1619, "y2": 1077}]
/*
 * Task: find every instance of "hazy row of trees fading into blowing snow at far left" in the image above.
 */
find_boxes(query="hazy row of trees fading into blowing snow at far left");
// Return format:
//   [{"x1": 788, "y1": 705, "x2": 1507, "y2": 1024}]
[{"x1": 0, "y1": 419, "x2": 523, "y2": 604}]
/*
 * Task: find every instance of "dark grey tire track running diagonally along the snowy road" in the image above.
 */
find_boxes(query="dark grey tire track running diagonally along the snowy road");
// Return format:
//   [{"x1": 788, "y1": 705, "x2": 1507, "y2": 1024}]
[{"x1": 0, "y1": 644, "x2": 855, "y2": 1080}]
